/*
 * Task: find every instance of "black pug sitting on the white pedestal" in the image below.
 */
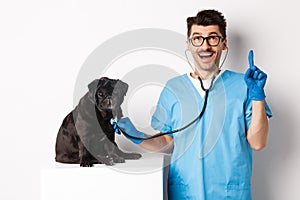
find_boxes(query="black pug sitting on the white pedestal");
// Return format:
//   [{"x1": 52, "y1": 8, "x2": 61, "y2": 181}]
[{"x1": 55, "y1": 77, "x2": 141, "y2": 167}]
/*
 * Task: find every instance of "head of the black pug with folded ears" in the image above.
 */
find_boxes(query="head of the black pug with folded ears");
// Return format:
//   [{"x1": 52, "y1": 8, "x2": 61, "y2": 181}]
[{"x1": 89, "y1": 77, "x2": 128, "y2": 111}]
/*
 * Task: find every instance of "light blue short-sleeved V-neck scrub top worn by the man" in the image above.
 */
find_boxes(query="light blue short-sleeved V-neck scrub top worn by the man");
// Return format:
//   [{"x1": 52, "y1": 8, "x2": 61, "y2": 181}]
[{"x1": 151, "y1": 70, "x2": 272, "y2": 200}]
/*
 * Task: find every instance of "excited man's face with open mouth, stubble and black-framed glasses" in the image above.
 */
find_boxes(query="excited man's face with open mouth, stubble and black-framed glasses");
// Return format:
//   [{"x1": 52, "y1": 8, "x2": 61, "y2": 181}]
[{"x1": 187, "y1": 25, "x2": 227, "y2": 73}]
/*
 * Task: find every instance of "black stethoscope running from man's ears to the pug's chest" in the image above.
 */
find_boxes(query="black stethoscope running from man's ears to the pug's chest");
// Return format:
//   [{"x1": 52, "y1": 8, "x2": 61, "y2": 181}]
[{"x1": 111, "y1": 47, "x2": 229, "y2": 140}]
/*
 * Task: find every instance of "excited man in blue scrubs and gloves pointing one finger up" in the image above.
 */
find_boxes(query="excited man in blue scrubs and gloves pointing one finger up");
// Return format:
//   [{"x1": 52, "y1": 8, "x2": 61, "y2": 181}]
[{"x1": 118, "y1": 10, "x2": 272, "y2": 200}]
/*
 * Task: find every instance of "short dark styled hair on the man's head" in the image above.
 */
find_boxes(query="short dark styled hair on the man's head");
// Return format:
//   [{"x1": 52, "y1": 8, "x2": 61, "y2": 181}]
[{"x1": 186, "y1": 10, "x2": 226, "y2": 38}]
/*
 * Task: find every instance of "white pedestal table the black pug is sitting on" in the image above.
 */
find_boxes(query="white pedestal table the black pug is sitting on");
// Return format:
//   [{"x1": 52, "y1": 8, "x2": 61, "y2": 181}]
[{"x1": 41, "y1": 154, "x2": 170, "y2": 200}]
